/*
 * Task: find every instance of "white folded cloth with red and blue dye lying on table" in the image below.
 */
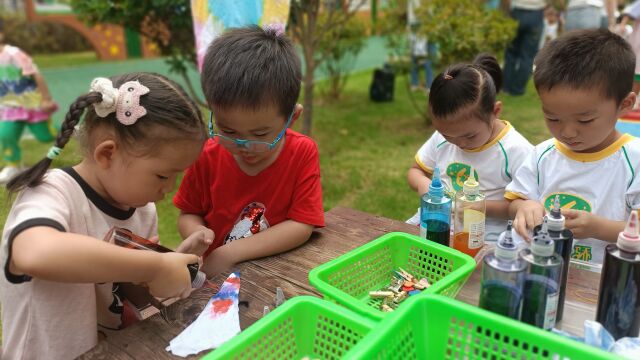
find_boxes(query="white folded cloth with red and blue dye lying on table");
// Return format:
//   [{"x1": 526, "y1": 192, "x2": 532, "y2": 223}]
[{"x1": 166, "y1": 272, "x2": 240, "y2": 357}]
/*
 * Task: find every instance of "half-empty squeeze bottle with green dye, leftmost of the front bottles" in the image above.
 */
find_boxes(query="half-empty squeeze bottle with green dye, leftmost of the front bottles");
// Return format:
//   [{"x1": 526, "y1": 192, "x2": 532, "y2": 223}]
[{"x1": 479, "y1": 220, "x2": 527, "y2": 320}]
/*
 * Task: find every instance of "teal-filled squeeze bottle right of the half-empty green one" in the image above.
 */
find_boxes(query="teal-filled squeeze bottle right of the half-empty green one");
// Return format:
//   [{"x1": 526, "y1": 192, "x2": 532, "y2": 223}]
[{"x1": 521, "y1": 219, "x2": 563, "y2": 330}]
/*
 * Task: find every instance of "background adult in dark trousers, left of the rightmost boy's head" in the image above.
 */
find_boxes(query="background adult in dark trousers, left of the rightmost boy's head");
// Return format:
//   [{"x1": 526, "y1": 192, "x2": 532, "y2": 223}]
[{"x1": 504, "y1": 0, "x2": 547, "y2": 95}]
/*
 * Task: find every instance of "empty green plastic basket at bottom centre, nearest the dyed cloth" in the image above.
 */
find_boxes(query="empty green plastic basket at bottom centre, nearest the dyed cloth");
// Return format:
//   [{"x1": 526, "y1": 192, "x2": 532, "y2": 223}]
[{"x1": 204, "y1": 296, "x2": 375, "y2": 360}]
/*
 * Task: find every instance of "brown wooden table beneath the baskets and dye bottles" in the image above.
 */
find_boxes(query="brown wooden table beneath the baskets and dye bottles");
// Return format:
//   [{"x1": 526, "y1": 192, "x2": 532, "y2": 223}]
[{"x1": 80, "y1": 207, "x2": 600, "y2": 359}]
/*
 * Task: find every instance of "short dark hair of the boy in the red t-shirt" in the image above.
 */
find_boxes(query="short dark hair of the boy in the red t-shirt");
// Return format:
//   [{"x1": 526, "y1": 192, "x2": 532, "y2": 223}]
[{"x1": 201, "y1": 26, "x2": 302, "y2": 116}]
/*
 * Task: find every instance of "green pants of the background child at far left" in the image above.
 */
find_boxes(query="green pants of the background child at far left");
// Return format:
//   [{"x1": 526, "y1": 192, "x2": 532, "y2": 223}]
[{"x1": 0, "y1": 120, "x2": 55, "y2": 166}]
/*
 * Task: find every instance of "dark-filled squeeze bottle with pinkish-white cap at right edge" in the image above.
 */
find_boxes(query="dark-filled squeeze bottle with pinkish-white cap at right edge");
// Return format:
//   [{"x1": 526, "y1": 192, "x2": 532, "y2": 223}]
[{"x1": 596, "y1": 210, "x2": 640, "y2": 340}]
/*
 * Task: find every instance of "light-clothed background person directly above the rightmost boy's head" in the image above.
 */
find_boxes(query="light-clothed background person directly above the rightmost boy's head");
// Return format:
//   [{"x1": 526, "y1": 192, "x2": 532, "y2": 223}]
[{"x1": 564, "y1": 0, "x2": 618, "y2": 31}]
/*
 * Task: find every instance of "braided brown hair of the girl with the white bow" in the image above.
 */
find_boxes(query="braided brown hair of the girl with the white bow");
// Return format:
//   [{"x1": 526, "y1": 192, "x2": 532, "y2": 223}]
[{"x1": 7, "y1": 73, "x2": 206, "y2": 193}]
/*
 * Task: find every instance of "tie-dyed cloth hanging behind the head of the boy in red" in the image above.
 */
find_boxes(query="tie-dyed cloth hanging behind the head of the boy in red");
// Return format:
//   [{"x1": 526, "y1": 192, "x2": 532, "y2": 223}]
[{"x1": 191, "y1": 0, "x2": 290, "y2": 69}]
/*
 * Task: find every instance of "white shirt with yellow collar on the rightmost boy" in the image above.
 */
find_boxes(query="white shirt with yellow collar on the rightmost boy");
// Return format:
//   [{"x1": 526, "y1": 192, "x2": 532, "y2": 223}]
[{"x1": 505, "y1": 134, "x2": 640, "y2": 269}]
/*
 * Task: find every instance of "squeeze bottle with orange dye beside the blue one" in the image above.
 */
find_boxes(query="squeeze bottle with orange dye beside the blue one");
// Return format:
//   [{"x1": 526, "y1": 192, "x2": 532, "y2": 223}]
[{"x1": 453, "y1": 168, "x2": 486, "y2": 256}]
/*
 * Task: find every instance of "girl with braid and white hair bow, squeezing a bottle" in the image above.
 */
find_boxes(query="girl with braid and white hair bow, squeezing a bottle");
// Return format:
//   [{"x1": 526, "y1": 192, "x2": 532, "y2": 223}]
[{"x1": 0, "y1": 73, "x2": 206, "y2": 359}]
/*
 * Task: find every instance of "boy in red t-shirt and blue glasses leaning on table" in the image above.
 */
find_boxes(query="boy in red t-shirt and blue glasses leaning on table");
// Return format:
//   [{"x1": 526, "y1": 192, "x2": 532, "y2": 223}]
[{"x1": 173, "y1": 27, "x2": 324, "y2": 276}]
